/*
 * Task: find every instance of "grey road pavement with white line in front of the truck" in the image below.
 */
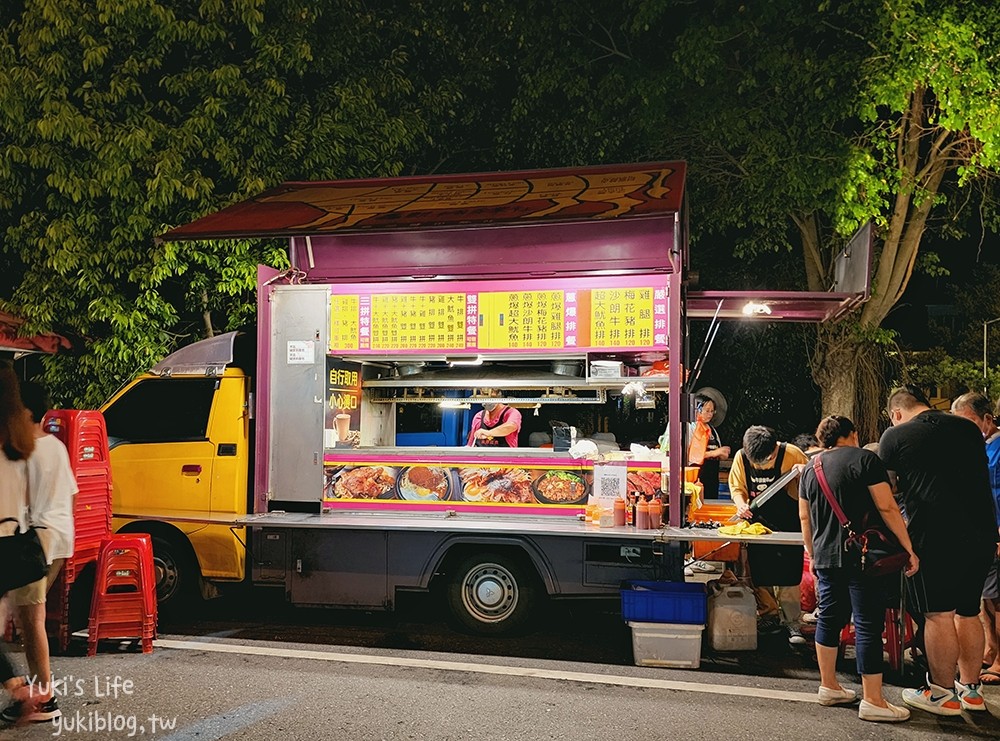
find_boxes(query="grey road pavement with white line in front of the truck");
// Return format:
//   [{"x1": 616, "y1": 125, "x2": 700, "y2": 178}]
[{"x1": 0, "y1": 635, "x2": 1000, "y2": 741}]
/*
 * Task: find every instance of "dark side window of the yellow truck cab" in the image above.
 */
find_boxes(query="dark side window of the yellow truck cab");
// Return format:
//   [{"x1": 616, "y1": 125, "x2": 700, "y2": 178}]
[{"x1": 104, "y1": 378, "x2": 218, "y2": 445}]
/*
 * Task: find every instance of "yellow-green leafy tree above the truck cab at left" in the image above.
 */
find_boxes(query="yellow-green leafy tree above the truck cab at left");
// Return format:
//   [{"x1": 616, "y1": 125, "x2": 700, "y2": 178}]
[{"x1": 0, "y1": 0, "x2": 468, "y2": 404}]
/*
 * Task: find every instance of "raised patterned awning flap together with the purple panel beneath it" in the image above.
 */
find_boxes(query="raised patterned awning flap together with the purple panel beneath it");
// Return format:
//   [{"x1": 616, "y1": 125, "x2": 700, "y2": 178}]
[{"x1": 160, "y1": 162, "x2": 687, "y2": 282}]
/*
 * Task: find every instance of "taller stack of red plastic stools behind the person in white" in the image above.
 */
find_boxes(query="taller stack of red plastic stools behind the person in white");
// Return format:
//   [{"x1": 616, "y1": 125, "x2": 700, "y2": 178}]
[{"x1": 42, "y1": 409, "x2": 111, "y2": 651}]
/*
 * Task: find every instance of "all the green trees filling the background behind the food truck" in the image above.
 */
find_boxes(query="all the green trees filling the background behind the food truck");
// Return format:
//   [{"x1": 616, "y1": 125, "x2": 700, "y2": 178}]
[{"x1": 0, "y1": 0, "x2": 1000, "y2": 420}]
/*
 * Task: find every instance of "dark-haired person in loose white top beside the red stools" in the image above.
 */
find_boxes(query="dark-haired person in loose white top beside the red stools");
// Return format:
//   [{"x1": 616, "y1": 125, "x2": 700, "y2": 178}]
[{"x1": 0, "y1": 381, "x2": 77, "y2": 722}]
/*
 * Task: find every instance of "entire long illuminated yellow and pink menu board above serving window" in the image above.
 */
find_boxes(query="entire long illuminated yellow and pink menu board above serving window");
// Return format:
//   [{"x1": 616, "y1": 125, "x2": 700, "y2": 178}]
[{"x1": 330, "y1": 276, "x2": 667, "y2": 354}]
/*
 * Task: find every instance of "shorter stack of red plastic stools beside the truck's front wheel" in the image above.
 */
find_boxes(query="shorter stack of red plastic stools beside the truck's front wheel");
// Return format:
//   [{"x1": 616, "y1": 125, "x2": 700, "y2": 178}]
[{"x1": 87, "y1": 533, "x2": 156, "y2": 656}]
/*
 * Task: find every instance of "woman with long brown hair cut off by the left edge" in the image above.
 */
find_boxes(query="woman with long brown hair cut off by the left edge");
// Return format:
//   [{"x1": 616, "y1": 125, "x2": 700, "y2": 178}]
[{"x1": 0, "y1": 364, "x2": 40, "y2": 715}]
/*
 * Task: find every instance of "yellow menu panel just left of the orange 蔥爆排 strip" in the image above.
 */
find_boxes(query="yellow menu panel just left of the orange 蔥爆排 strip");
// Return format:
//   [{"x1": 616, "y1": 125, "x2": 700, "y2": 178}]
[{"x1": 479, "y1": 291, "x2": 564, "y2": 350}]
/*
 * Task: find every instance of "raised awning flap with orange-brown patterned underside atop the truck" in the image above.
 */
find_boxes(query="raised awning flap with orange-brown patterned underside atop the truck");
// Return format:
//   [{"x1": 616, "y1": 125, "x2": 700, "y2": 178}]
[{"x1": 160, "y1": 162, "x2": 686, "y2": 241}]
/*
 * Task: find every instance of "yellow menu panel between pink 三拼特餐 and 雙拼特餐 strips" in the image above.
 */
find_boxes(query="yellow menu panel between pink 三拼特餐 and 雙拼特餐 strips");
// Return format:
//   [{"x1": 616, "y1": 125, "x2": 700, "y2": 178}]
[{"x1": 370, "y1": 293, "x2": 465, "y2": 350}]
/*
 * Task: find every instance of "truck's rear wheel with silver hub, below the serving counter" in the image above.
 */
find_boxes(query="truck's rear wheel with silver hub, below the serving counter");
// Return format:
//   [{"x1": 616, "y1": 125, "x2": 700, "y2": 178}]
[{"x1": 448, "y1": 553, "x2": 540, "y2": 635}]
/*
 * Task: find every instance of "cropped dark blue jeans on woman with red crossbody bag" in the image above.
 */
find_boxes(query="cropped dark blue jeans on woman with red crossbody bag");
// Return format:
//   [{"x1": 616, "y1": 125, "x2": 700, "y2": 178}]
[{"x1": 816, "y1": 568, "x2": 898, "y2": 674}]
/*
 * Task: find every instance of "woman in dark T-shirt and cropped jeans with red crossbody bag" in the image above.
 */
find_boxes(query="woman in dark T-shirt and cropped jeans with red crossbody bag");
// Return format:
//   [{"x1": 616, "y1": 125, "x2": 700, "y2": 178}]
[{"x1": 799, "y1": 415, "x2": 919, "y2": 722}]
